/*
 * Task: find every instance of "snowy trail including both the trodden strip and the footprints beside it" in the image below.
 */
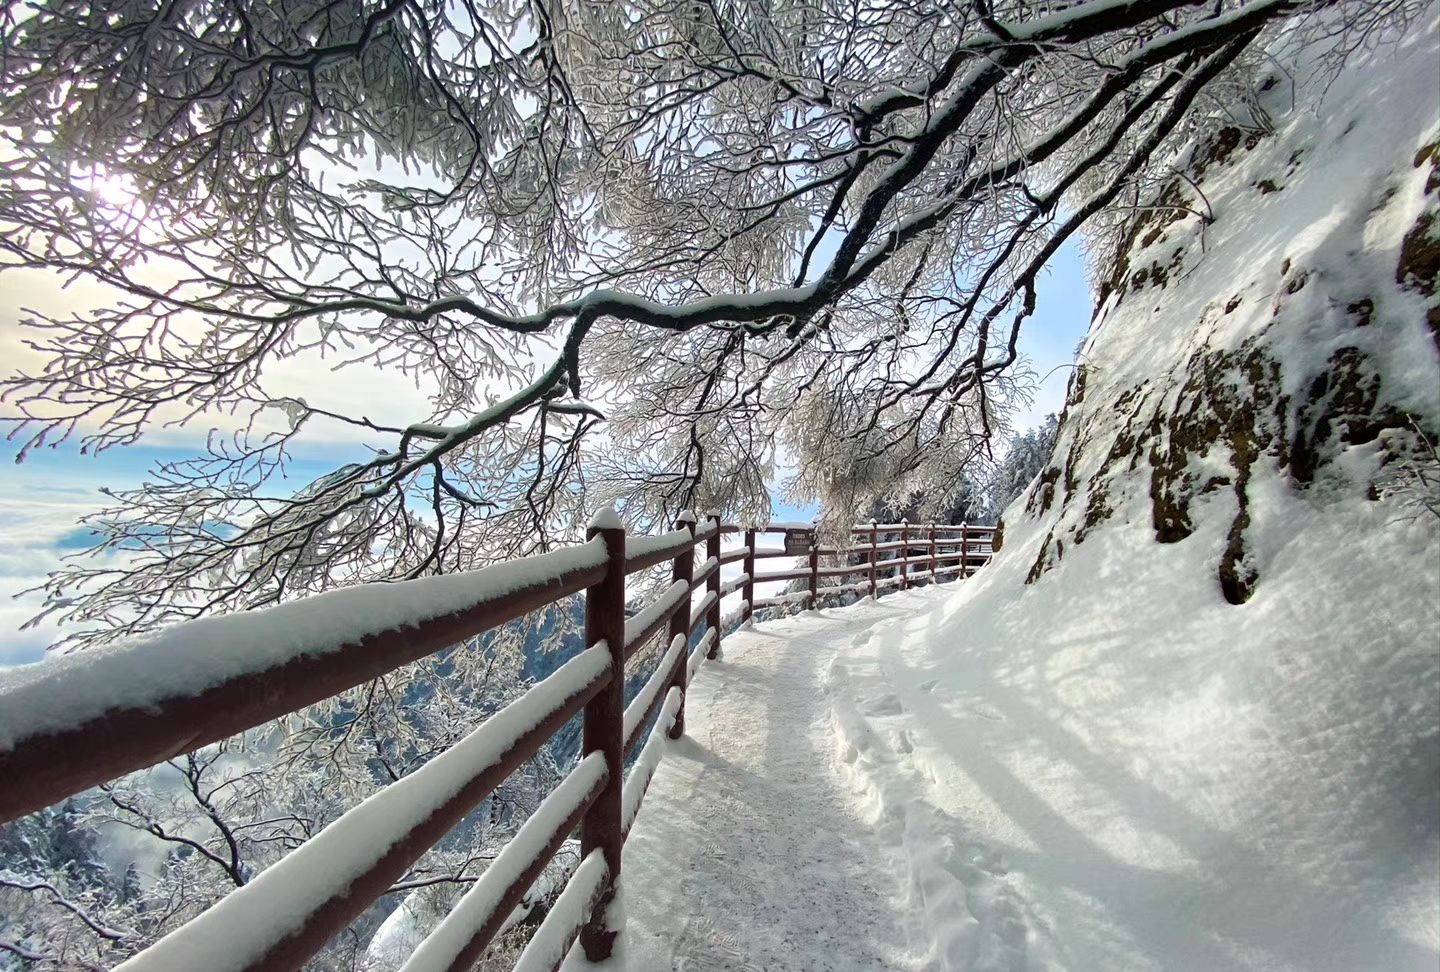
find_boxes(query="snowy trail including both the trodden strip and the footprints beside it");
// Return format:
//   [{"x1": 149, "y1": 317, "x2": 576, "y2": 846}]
[{"x1": 567, "y1": 592, "x2": 1027, "y2": 972}]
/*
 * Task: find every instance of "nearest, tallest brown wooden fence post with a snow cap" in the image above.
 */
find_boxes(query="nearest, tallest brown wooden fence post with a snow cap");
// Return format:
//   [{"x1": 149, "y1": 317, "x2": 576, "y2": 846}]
[{"x1": 580, "y1": 510, "x2": 625, "y2": 962}]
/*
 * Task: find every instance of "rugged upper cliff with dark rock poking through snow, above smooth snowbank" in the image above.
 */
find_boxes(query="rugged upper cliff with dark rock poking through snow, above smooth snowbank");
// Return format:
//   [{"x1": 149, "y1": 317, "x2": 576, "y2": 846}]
[{"x1": 1009, "y1": 18, "x2": 1440, "y2": 605}]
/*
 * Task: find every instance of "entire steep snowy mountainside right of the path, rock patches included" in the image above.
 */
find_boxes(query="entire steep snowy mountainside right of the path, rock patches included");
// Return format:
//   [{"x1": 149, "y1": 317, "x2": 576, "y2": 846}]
[{"x1": 835, "y1": 19, "x2": 1440, "y2": 971}]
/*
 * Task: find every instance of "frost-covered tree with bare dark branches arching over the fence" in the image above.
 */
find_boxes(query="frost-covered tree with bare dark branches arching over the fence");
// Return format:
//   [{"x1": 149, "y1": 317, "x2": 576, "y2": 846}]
[{"x1": 0, "y1": 0, "x2": 1378, "y2": 644}]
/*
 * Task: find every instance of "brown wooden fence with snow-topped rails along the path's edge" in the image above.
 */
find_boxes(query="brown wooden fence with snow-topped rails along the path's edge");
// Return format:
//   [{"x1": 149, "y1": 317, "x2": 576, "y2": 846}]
[{"x1": 0, "y1": 511, "x2": 994, "y2": 972}]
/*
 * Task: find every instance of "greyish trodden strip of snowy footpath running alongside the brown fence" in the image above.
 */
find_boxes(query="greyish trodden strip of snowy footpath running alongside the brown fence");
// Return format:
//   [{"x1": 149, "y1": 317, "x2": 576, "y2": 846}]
[{"x1": 587, "y1": 605, "x2": 933, "y2": 972}]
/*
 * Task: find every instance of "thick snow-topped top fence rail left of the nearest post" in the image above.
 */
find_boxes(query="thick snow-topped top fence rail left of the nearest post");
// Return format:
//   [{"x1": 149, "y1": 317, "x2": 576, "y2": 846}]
[{"x1": 0, "y1": 543, "x2": 606, "y2": 821}]
